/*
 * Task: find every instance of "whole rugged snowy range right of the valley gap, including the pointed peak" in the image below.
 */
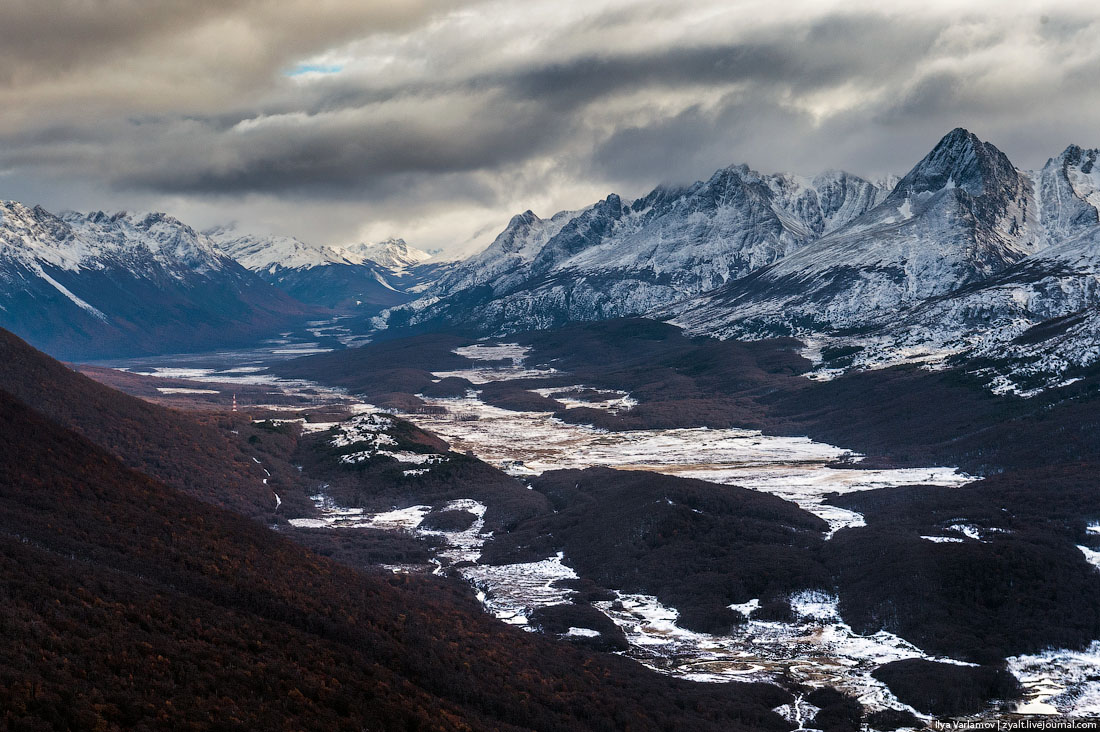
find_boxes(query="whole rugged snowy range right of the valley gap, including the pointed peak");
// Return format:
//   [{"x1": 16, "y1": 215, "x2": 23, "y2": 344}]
[{"x1": 378, "y1": 129, "x2": 1100, "y2": 393}]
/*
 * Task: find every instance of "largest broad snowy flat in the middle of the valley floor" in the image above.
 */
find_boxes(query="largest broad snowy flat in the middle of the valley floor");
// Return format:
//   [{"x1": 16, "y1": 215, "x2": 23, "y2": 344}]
[{"x1": 416, "y1": 393, "x2": 975, "y2": 533}]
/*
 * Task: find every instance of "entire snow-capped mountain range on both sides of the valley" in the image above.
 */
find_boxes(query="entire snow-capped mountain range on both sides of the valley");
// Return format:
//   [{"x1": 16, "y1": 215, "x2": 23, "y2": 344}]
[{"x1": 8, "y1": 124, "x2": 1100, "y2": 387}]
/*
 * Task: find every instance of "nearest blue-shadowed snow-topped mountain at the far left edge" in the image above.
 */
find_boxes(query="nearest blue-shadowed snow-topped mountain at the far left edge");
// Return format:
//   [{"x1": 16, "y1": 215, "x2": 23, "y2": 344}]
[{"x1": 0, "y1": 201, "x2": 305, "y2": 359}]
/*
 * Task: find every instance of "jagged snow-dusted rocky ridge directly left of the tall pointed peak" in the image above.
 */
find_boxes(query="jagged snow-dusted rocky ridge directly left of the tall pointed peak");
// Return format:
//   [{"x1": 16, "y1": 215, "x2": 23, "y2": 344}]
[{"x1": 388, "y1": 165, "x2": 886, "y2": 332}]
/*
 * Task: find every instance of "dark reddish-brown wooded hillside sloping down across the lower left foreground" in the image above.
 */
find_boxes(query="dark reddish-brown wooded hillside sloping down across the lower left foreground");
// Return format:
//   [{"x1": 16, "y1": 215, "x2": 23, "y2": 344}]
[{"x1": 0, "y1": 392, "x2": 789, "y2": 730}]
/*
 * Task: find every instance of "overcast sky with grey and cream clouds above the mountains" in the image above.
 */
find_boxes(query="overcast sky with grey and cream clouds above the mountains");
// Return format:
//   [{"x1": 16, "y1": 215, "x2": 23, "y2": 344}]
[{"x1": 0, "y1": 0, "x2": 1100, "y2": 256}]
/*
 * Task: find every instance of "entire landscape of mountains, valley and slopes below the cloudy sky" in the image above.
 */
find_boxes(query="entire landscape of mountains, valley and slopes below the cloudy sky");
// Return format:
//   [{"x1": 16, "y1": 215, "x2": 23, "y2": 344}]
[{"x1": 0, "y1": 129, "x2": 1100, "y2": 732}]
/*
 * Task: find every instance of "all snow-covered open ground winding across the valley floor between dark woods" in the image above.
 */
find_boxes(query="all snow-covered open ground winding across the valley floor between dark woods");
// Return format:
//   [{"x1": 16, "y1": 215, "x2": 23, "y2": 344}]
[{"x1": 94, "y1": 325, "x2": 1100, "y2": 725}]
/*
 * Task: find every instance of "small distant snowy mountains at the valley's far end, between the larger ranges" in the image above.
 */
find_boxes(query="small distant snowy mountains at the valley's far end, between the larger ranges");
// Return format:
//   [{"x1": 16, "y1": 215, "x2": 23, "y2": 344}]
[{"x1": 207, "y1": 227, "x2": 440, "y2": 309}]
